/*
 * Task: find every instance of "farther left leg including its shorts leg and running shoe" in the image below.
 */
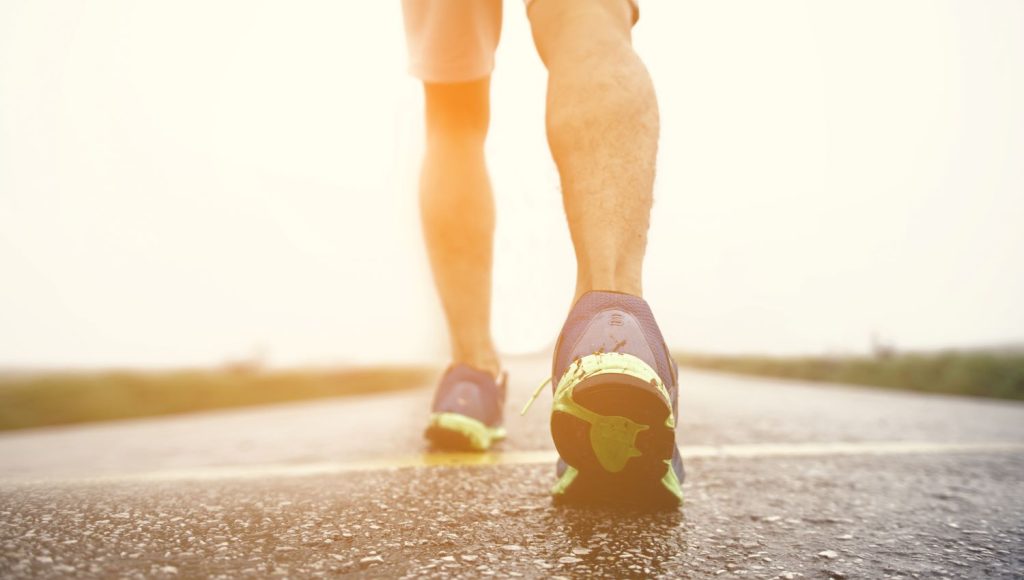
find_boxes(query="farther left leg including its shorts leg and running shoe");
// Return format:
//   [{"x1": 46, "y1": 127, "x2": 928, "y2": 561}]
[{"x1": 401, "y1": 0, "x2": 506, "y2": 451}]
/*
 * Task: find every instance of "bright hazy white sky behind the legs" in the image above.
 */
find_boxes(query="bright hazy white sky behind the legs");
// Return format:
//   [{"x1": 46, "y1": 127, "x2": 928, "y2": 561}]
[{"x1": 0, "y1": 0, "x2": 1024, "y2": 366}]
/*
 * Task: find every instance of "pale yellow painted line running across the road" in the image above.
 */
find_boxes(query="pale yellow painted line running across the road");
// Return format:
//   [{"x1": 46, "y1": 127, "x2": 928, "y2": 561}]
[{"x1": 0, "y1": 442, "x2": 1024, "y2": 485}]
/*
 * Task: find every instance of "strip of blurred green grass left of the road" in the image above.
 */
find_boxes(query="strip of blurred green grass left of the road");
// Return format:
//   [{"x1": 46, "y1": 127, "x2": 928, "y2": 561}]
[{"x1": 0, "y1": 367, "x2": 435, "y2": 430}]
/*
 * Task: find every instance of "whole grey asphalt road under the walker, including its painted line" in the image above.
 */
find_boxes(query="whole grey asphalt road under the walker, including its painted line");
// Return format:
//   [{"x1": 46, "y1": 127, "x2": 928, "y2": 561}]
[{"x1": 0, "y1": 360, "x2": 1024, "y2": 578}]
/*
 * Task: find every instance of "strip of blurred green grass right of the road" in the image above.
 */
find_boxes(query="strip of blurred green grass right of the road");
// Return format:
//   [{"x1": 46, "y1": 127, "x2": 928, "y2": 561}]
[{"x1": 676, "y1": 350, "x2": 1024, "y2": 400}]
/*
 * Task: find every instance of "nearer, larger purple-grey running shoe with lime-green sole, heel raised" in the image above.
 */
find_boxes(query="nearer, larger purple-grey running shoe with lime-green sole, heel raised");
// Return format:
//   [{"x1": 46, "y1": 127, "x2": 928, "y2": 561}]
[{"x1": 523, "y1": 291, "x2": 684, "y2": 507}]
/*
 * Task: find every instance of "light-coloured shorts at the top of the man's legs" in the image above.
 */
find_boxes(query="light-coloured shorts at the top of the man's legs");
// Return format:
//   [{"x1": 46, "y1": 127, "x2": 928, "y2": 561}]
[{"x1": 401, "y1": 0, "x2": 639, "y2": 83}]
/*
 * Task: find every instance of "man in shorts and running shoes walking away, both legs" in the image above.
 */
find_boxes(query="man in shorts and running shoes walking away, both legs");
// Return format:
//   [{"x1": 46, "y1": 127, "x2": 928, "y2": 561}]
[{"x1": 403, "y1": 0, "x2": 683, "y2": 505}]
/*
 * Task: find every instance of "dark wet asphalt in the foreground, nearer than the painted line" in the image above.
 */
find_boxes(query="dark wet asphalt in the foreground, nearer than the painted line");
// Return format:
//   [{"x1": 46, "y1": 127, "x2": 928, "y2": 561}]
[{"x1": 0, "y1": 454, "x2": 1024, "y2": 578}]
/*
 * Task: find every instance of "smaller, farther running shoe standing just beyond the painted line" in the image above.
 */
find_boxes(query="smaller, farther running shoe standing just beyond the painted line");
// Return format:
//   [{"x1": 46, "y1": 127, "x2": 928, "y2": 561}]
[{"x1": 424, "y1": 364, "x2": 508, "y2": 451}]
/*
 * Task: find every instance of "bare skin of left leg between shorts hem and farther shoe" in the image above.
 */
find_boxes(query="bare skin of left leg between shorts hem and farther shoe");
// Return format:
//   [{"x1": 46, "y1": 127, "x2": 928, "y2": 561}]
[{"x1": 420, "y1": 77, "x2": 500, "y2": 376}]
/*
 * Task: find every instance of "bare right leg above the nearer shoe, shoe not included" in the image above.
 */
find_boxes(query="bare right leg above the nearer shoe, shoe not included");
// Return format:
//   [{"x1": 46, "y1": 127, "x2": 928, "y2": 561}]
[{"x1": 528, "y1": 0, "x2": 658, "y2": 299}]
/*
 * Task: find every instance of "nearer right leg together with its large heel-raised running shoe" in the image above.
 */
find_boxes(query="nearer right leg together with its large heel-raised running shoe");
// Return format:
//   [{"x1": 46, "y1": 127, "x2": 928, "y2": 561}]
[{"x1": 529, "y1": 0, "x2": 684, "y2": 507}]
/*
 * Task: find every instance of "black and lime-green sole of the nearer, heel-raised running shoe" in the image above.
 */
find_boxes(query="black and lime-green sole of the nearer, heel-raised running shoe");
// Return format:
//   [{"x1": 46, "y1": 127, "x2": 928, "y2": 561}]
[{"x1": 551, "y1": 353, "x2": 683, "y2": 507}]
